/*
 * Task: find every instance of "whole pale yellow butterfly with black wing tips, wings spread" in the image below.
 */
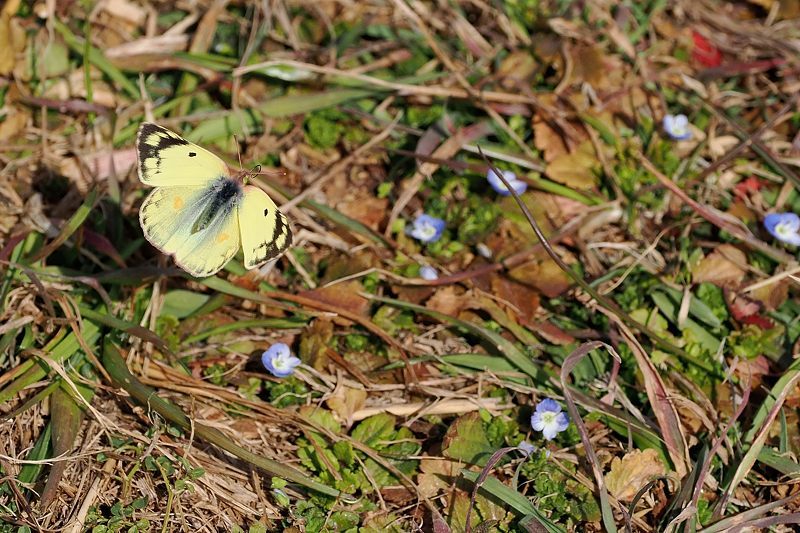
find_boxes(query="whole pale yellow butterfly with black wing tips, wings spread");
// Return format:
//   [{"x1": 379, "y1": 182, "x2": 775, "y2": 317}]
[{"x1": 136, "y1": 122, "x2": 292, "y2": 278}]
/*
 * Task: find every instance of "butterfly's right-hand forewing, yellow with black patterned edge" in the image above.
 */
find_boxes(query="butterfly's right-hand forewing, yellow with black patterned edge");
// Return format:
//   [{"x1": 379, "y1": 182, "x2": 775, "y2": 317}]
[{"x1": 239, "y1": 185, "x2": 292, "y2": 269}]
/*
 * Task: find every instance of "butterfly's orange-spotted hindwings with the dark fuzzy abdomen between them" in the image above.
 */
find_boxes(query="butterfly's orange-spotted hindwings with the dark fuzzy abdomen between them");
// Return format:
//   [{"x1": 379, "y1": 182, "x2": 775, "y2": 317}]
[{"x1": 139, "y1": 179, "x2": 241, "y2": 277}]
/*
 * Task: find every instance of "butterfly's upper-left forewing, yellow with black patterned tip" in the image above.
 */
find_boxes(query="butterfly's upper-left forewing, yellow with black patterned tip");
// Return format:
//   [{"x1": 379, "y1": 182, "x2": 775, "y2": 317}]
[{"x1": 136, "y1": 122, "x2": 228, "y2": 187}]
